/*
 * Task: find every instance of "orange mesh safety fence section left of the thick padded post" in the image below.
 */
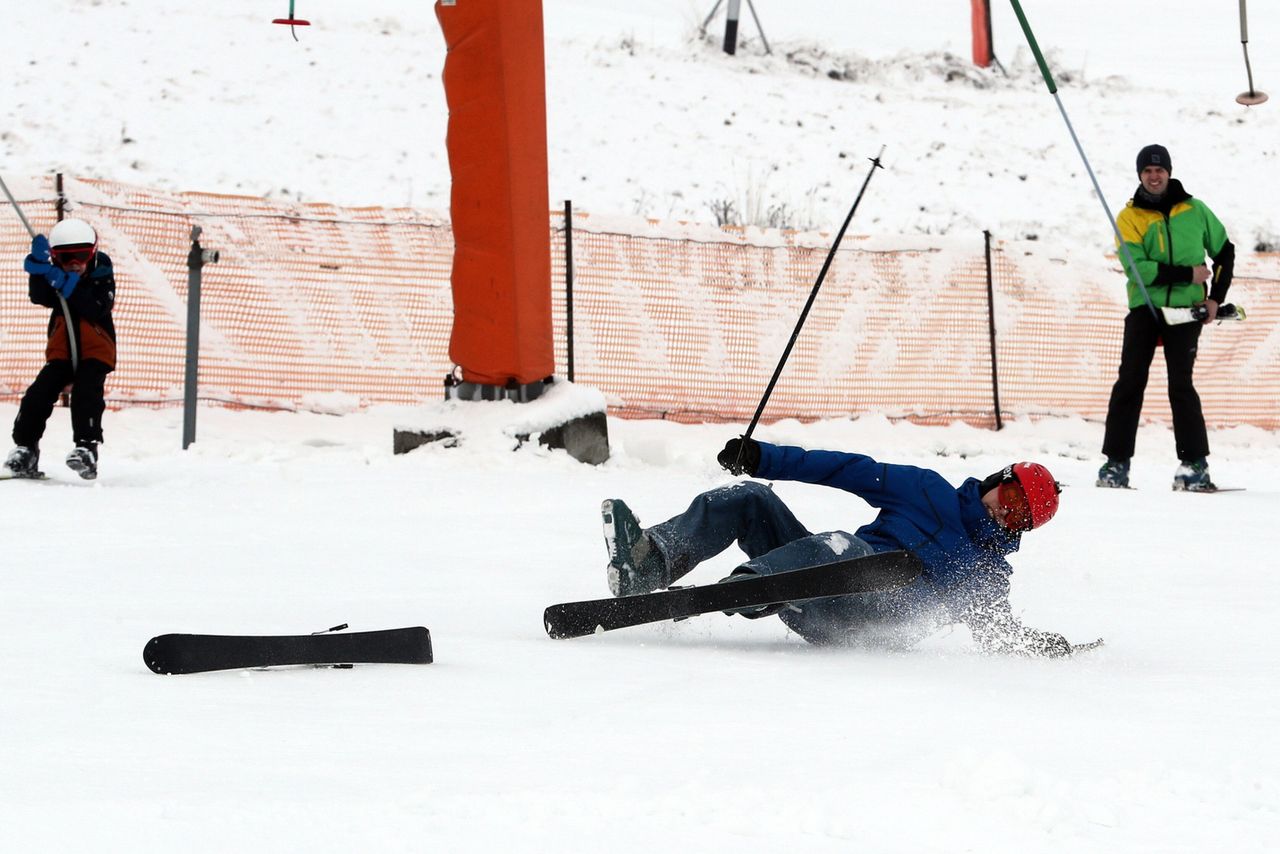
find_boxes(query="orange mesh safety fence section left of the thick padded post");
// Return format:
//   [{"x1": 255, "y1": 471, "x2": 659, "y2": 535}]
[{"x1": 0, "y1": 175, "x2": 453, "y2": 408}]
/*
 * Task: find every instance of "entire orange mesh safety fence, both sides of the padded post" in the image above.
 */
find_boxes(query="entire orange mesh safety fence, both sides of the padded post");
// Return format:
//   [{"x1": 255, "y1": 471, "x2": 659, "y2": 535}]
[{"x1": 0, "y1": 174, "x2": 1280, "y2": 429}]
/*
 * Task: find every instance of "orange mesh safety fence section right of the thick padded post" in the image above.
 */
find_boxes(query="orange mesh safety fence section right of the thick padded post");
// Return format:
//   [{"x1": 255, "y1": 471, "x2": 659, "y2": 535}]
[{"x1": 552, "y1": 218, "x2": 1280, "y2": 429}]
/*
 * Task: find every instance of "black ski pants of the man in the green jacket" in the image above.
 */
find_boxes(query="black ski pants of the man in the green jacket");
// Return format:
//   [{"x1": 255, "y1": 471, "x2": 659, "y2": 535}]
[{"x1": 1102, "y1": 306, "x2": 1208, "y2": 468}]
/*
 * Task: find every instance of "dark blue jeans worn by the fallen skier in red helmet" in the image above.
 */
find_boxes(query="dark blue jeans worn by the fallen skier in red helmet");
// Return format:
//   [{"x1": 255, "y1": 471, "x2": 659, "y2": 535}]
[{"x1": 645, "y1": 480, "x2": 918, "y2": 644}]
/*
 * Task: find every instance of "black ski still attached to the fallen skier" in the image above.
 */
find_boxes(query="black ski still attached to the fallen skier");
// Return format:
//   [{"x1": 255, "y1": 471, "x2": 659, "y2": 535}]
[{"x1": 543, "y1": 552, "x2": 922, "y2": 638}]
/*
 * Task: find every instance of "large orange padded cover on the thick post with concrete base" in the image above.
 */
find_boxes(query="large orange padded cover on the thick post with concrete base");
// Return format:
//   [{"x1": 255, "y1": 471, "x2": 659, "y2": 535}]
[{"x1": 435, "y1": 0, "x2": 556, "y2": 385}]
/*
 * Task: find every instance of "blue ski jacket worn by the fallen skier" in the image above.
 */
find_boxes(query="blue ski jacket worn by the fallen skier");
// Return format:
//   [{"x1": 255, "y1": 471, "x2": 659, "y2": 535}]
[{"x1": 755, "y1": 442, "x2": 1021, "y2": 626}]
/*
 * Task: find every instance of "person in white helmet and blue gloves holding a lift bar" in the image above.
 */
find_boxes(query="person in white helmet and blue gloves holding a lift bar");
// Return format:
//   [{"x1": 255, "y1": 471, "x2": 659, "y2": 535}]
[{"x1": 4, "y1": 219, "x2": 115, "y2": 480}]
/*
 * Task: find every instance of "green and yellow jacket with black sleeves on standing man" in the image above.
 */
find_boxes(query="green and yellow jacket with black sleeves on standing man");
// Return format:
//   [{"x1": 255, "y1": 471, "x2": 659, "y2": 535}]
[{"x1": 1116, "y1": 178, "x2": 1235, "y2": 309}]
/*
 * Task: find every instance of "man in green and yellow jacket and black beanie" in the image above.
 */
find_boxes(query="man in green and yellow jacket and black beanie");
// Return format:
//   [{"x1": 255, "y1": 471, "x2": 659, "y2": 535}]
[{"x1": 1097, "y1": 145, "x2": 1235, "y2": 492}]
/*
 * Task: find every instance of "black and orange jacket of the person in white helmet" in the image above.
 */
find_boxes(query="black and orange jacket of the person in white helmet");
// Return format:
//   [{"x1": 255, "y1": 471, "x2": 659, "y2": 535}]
[{"x1": 27, "y1": 252, "x2": 115, "y2": 369}]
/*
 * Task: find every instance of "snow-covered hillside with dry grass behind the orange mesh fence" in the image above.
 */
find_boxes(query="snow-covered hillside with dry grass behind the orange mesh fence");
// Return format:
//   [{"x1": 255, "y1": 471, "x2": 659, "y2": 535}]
[{"x1": 0, "y1": 0, "x2": 1280, "y2": 252}]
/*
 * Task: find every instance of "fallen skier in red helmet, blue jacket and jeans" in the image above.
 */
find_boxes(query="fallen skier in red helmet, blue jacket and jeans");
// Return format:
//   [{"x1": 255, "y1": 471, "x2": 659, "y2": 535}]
[{"x1": 602, "y1": 438, "x2": 1090, "y2": 657}]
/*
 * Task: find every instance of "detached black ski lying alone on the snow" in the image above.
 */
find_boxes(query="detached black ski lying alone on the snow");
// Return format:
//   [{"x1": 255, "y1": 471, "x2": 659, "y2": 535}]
[{"x1": 142, "y1": 626, "x2": 431, "y2": 673}]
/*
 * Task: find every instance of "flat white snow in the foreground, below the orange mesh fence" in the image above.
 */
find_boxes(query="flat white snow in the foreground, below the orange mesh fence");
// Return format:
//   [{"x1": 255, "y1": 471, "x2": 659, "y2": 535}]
[{"x1": 0, "y1": 403, "x2": 1280, "y2": 854}]
